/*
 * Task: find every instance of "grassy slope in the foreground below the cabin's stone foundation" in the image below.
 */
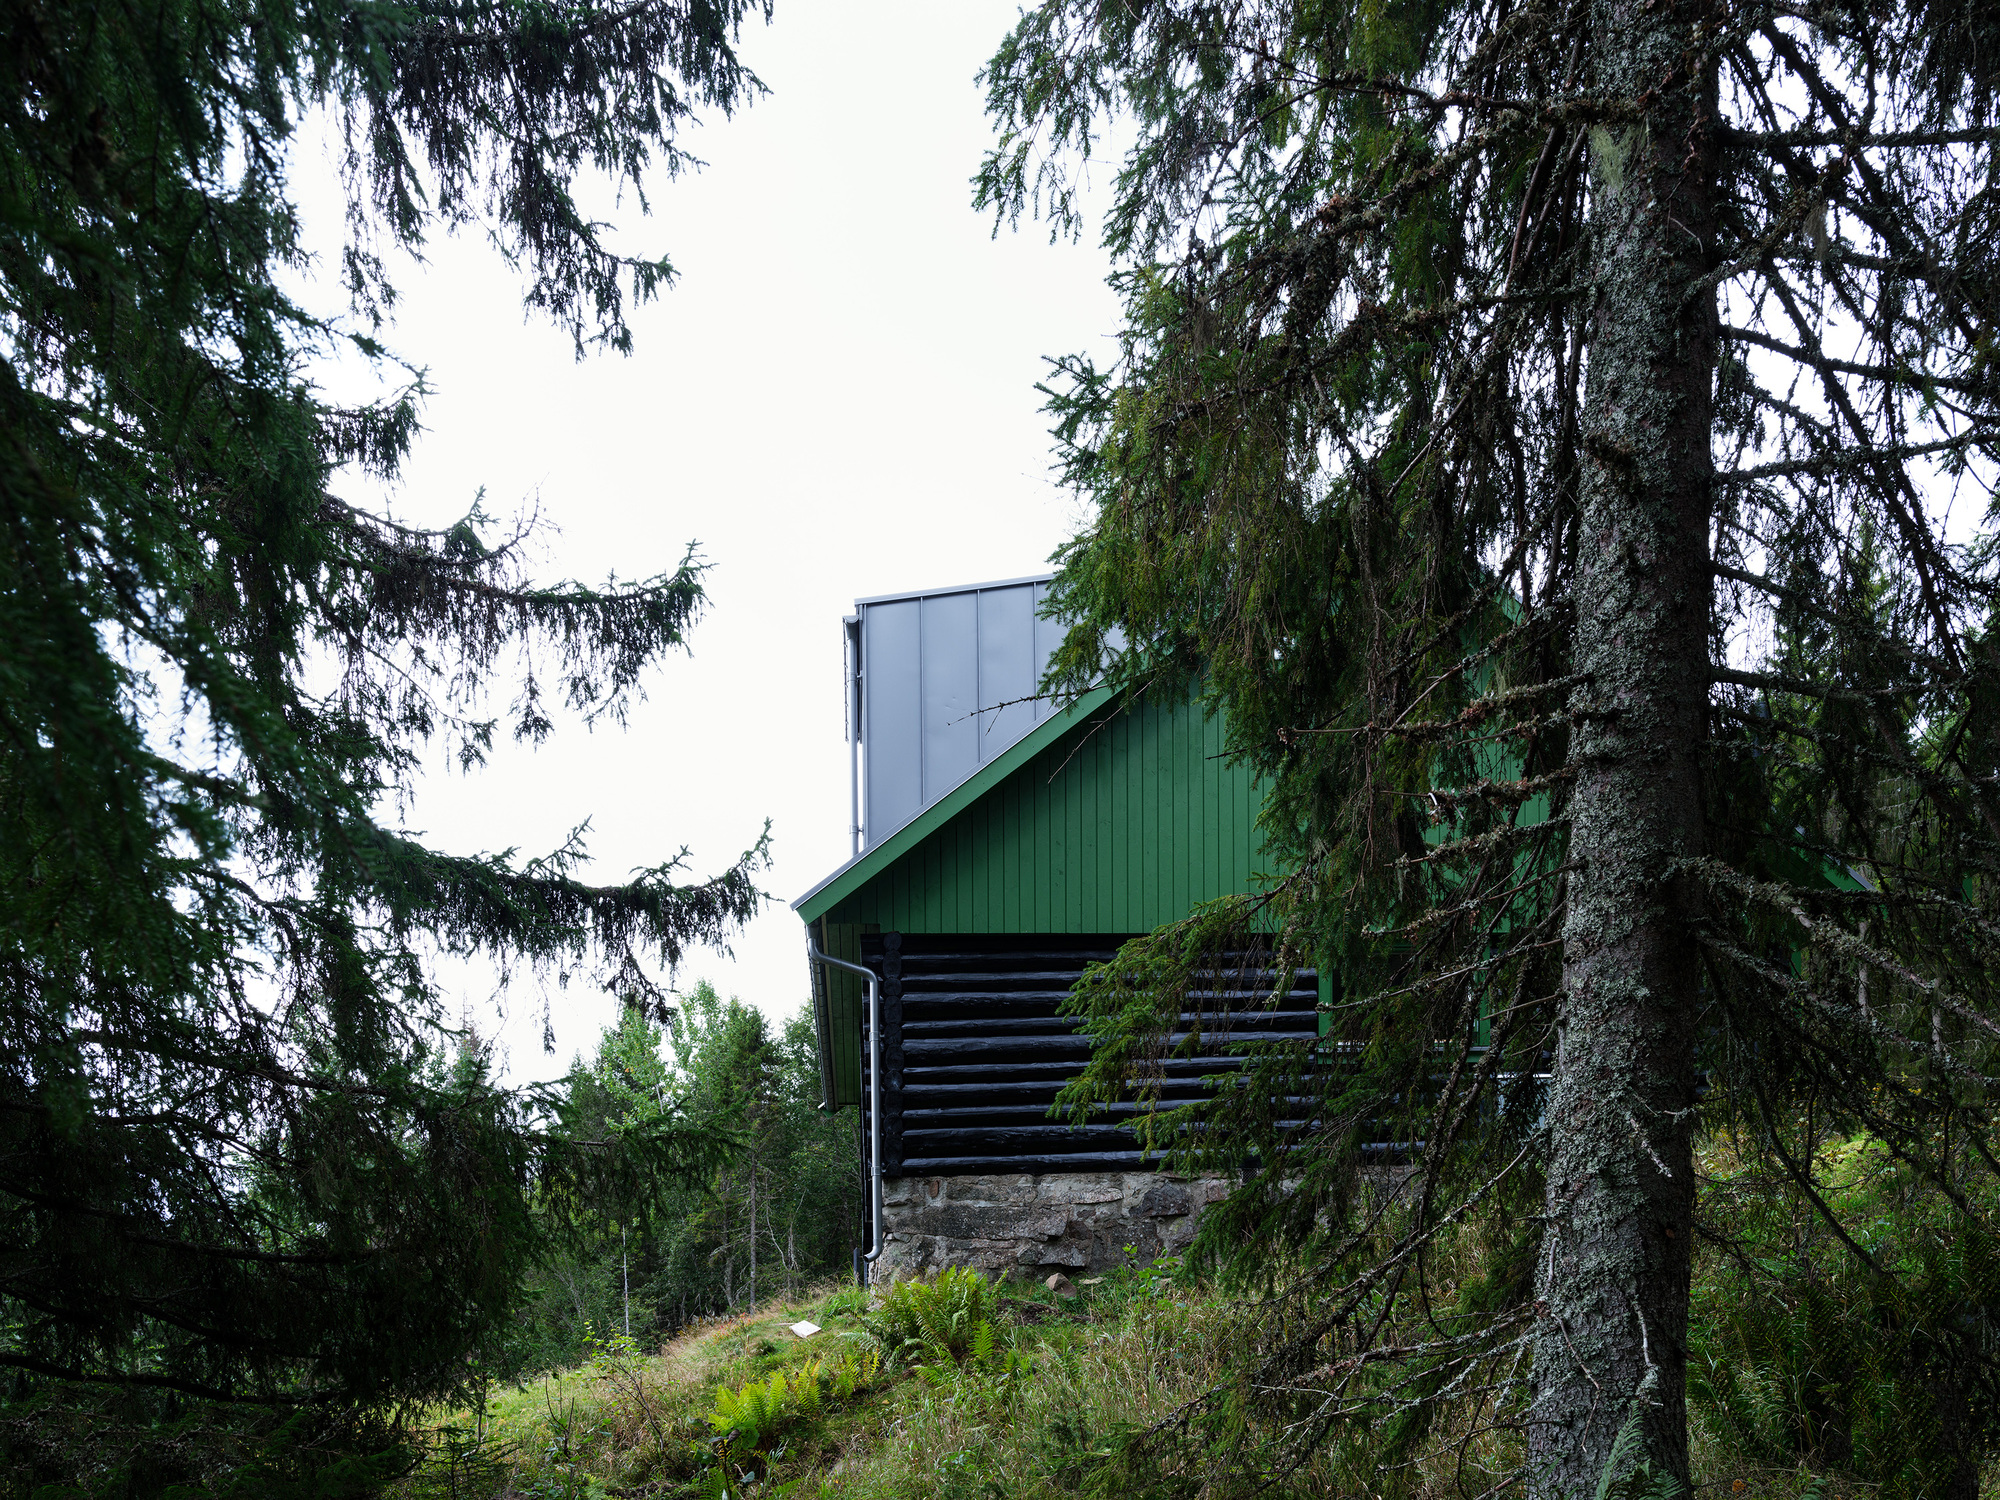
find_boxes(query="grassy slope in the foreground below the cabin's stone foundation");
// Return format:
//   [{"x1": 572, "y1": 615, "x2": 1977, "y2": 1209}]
[{"x1": 398, "y1": 1270, "x2": 1968, "y2": 1500}]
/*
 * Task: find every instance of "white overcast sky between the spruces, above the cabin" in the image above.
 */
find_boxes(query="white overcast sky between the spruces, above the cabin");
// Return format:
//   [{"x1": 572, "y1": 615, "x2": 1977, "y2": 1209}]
[{"x1": 294, "y1": 0, "x2": 1116, "y2": 1080}]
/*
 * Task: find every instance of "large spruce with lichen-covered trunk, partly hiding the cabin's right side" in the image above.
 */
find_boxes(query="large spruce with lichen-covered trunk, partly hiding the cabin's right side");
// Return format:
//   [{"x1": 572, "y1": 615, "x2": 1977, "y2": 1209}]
[{"x1": 978, "y1": 0, "x2": 2000, "y2": 1498}]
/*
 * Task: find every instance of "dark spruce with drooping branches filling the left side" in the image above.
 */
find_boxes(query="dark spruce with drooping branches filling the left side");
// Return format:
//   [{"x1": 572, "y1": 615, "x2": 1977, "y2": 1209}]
[{"x1": 0, "y1": 0, "x2": 764, "y2": 1406}]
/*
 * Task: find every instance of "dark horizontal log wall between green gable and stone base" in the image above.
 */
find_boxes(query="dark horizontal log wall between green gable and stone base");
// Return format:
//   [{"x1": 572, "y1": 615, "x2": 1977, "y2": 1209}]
[{"x1": 862, "y1": 932, "x2": 1320, "y2": 1178}]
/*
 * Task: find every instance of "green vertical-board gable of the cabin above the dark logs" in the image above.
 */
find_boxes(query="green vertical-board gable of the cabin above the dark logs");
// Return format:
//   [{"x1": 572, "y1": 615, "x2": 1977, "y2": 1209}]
[{"x1": 800, "y1": 698, "x2": 1262, "y2": 1106}]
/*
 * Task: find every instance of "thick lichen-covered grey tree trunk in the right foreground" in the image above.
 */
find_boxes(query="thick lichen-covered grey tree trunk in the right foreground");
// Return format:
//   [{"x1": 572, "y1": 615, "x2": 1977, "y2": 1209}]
[{"x1": 1528, "y1": 0, "x2": 1716, "y2": 1500}]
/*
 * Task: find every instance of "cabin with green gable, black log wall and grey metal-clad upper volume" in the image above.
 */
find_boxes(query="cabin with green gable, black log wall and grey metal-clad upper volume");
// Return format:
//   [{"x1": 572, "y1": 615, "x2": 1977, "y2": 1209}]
[{"x1": 794, "y1": 578, "x2": 1320, "y2": 1256}]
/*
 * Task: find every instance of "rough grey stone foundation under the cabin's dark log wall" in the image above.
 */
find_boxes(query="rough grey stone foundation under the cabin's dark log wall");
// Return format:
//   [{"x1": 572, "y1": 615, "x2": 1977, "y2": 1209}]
[{"x1": 870, "y1": 1172, "x2": 1228, "y2": 1284}]
